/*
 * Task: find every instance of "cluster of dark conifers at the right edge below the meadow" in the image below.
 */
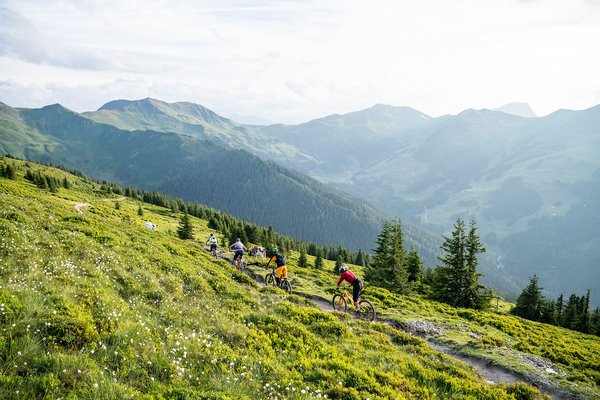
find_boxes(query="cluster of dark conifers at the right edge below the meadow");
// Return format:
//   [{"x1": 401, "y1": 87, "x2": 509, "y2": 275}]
[{"x1": 512, "y1": 275, "x2": 600, "y2": 336}]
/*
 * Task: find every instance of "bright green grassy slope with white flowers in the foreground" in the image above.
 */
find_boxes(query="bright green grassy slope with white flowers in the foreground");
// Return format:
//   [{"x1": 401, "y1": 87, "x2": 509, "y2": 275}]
[{"x1": 0, "y1": 158, "x2": 600, "y2": 399}]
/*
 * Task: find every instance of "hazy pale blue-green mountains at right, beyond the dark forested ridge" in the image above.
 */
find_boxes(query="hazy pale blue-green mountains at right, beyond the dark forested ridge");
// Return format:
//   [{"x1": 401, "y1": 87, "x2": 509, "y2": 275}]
[{"x1": 264, "y1": 106, "x2": 600, "y2": 304}]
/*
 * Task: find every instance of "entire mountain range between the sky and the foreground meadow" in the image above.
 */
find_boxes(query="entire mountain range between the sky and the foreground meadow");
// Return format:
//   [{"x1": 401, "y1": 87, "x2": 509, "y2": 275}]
[{"x1": 0, "y1": 99, "x2": 600, "y2": 303}]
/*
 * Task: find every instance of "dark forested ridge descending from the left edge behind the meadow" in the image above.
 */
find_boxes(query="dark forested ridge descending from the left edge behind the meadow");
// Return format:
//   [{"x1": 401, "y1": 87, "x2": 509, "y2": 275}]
[{"x1": 0, "y1": 101, "x2": 392, "y2": 252}]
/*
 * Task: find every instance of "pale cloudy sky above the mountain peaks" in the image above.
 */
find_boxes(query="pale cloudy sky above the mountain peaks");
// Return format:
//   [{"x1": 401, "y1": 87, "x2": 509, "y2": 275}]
[{"x1": 0, "y1": 0, "x2": 600, "y2": 123}]
